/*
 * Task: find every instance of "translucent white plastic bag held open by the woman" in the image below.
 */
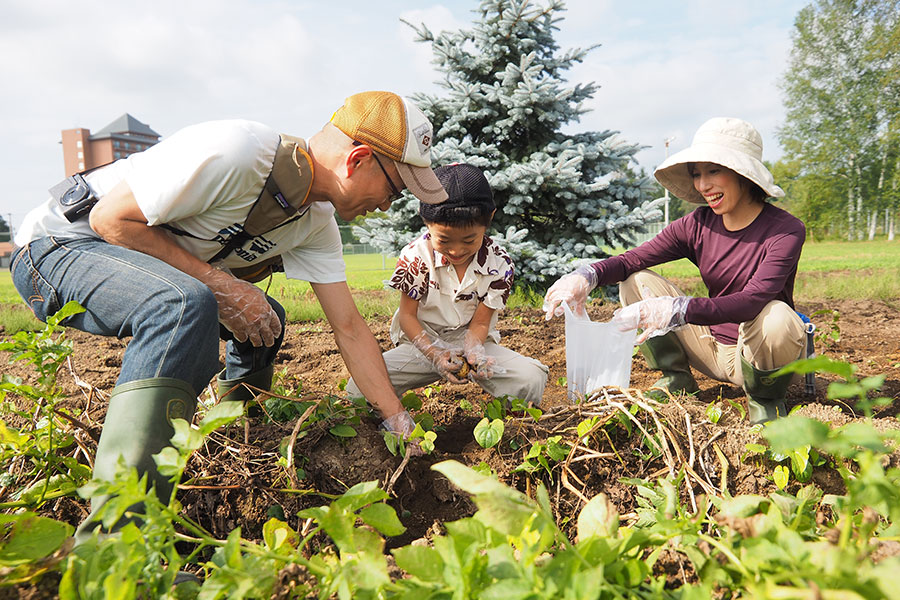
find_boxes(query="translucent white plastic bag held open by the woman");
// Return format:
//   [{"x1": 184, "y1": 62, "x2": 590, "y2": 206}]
[{"x1": 563, "y1": 303, "x2": 637, "y2": 401}]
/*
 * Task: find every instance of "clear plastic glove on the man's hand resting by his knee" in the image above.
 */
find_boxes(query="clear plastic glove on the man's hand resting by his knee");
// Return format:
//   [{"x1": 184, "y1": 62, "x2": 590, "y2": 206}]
[{"x1": 200, "y1": 267, "x2": 281, "y2": 347}]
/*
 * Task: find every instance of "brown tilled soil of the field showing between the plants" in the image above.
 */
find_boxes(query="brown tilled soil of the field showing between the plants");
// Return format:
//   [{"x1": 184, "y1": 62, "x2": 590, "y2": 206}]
[{"x1": 0, "y1": 301, "x2": 900, "y2": 597}]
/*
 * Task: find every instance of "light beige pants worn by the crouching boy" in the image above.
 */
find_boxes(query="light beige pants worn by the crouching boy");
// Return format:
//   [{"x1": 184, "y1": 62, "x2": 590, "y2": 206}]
[{"x1": 347, "y1": 328, "x2": 549, "y2": 406}]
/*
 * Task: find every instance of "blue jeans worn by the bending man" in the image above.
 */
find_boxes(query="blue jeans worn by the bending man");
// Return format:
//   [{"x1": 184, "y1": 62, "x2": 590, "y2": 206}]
[{"x1": 10, "y1": 236, "x2": 285, "y2": 392}]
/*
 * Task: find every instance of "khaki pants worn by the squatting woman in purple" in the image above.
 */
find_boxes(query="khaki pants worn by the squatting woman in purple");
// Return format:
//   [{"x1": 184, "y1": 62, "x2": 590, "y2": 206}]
[{"x1": 619, "y1": 270, "x2": 806, "y2": 385}]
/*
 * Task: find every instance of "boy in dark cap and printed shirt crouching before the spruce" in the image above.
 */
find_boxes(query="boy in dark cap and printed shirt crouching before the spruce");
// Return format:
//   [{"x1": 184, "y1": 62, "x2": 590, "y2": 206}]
[{"x1": 347, "y1": 164, "x2": 548, "y2": 431}]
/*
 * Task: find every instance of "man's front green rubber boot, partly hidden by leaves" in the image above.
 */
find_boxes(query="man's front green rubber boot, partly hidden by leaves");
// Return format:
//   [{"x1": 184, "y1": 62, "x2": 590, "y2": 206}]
[{"x1": 75, "y1": 377, "x2": 197, "y2": 543}]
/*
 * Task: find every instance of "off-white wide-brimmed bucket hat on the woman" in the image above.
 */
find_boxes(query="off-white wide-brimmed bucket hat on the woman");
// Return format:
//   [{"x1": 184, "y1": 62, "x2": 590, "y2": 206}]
[{"x1": 653, "y1": 117, "x2": 784, "y2": 204}]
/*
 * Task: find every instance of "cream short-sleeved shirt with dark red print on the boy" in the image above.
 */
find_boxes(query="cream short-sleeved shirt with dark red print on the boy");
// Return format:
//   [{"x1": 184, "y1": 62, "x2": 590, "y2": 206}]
[{"x1": 388, "y1": 232, "x2": 514, "y2": 344}]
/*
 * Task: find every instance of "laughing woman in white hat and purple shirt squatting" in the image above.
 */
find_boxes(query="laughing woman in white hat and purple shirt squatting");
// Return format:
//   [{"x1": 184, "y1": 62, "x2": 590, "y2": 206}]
[{"x1": 544, "y1": 118, "x2": 806, "y2": 424}]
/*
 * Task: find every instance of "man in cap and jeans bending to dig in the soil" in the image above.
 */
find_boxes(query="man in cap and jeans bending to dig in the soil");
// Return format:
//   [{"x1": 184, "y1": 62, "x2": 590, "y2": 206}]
[{"x1": 10, "y1": 92, "x2": 446, "y2": 537}]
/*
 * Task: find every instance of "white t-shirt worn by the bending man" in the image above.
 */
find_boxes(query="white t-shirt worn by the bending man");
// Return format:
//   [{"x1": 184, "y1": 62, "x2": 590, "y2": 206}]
[{"x1": 15, "y1": 120, "x2": 346, "y2": 283}]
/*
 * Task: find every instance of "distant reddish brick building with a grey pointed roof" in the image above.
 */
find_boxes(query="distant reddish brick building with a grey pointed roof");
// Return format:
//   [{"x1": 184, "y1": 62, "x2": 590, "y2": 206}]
[{"x1": 62, "y1": 113, "x2": 159, "y2": 177}]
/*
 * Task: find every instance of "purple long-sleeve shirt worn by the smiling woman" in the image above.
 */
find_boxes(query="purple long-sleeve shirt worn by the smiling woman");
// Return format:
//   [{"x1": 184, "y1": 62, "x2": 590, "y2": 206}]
[{"x1": 591, "y1": 203, "x2": 806, "y2": 344}]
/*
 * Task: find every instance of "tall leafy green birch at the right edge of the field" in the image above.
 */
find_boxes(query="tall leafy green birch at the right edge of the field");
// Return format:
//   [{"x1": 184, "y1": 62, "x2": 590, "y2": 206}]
[{"x1": 779, "y1": 0, "x2": 900, "y2": 239}]
